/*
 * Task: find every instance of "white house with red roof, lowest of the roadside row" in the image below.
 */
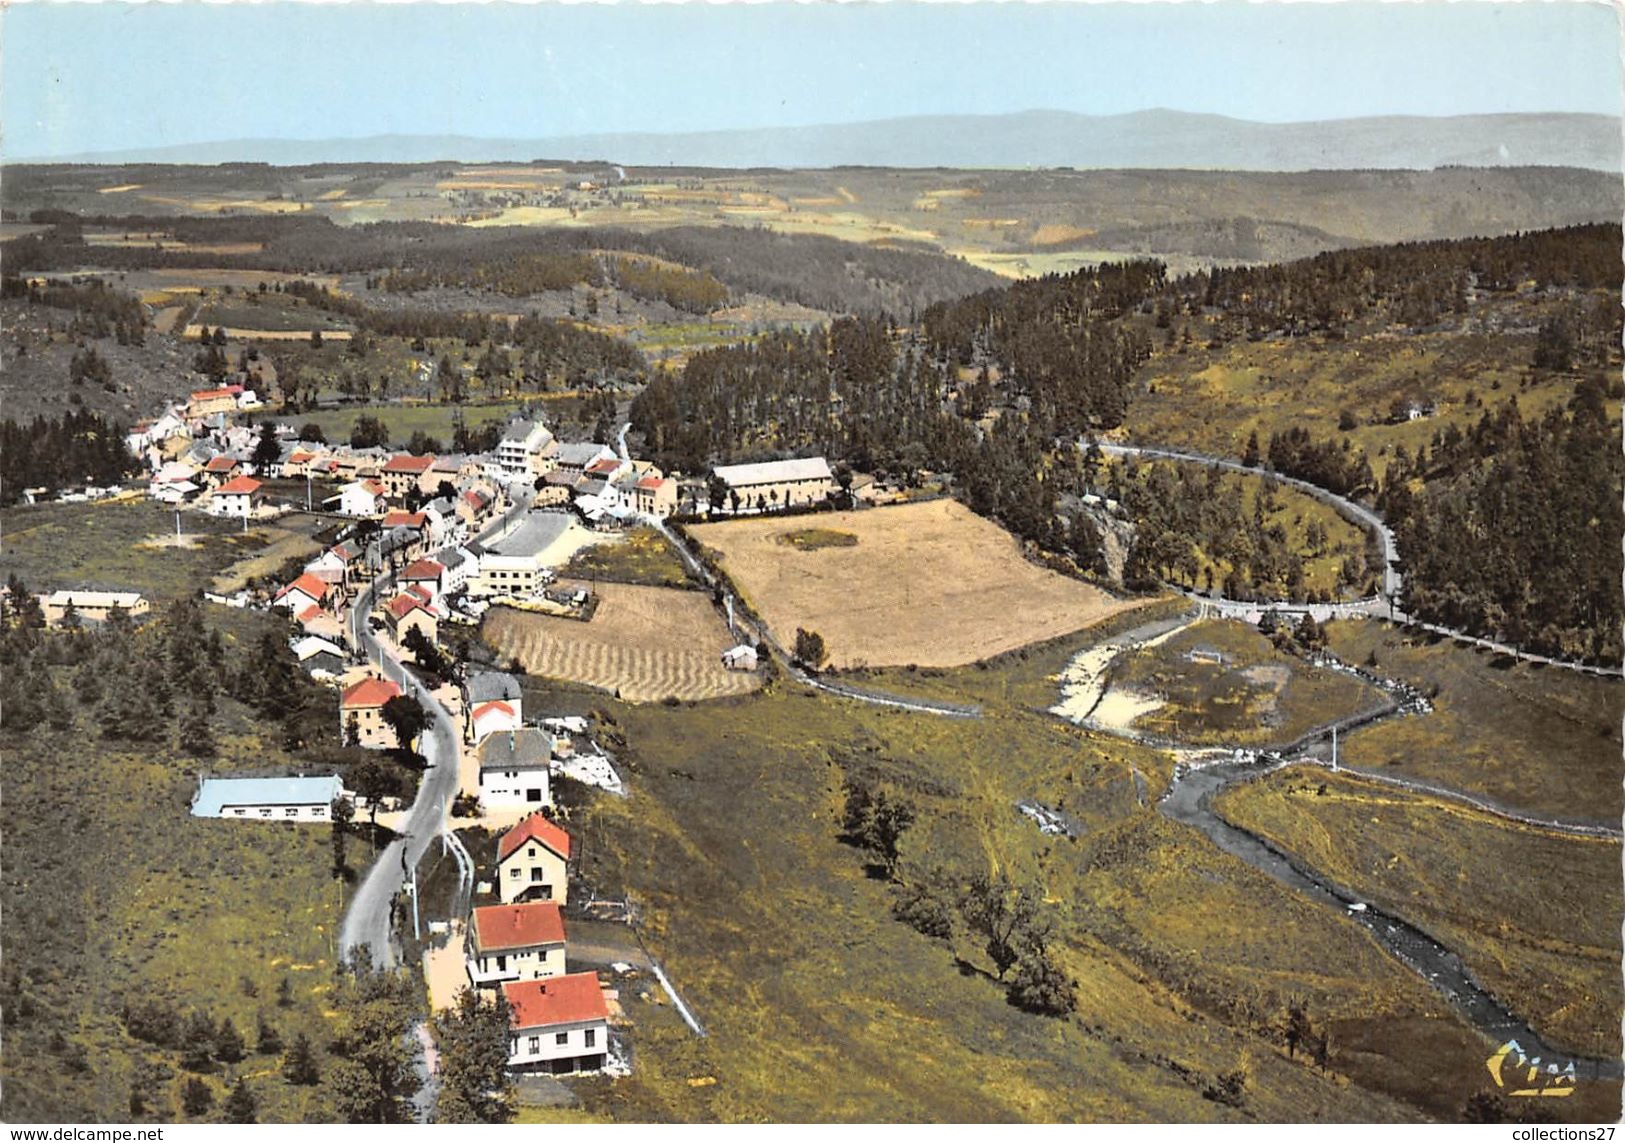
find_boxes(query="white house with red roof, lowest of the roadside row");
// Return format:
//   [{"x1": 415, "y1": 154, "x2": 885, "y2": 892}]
[{"x1": 502, "y1": 972, "x2": 609, "y2": 1075}]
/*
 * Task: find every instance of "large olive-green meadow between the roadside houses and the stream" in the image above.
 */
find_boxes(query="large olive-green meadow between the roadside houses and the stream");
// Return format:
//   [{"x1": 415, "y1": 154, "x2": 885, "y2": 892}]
[{"x1": 536, "y1": 640, "x2": 1625, "y2": 1122}]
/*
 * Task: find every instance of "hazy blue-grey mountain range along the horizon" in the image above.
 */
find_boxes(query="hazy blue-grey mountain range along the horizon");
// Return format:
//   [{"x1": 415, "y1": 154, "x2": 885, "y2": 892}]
[{"x1": 16, "y1": 111, "x2": 1622, "y2": 171}]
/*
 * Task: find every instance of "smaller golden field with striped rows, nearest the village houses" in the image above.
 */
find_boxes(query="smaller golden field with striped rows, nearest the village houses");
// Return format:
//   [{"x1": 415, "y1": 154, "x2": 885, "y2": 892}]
[{"x1": 483, "y1": 584, "x2": 762, "y2": 702}]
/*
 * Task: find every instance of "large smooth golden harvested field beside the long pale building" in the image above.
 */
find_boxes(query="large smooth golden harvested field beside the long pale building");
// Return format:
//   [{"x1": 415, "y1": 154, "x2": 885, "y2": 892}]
[{"x1": 691, "y1": 499, "x2": 1131, "y2": 667}]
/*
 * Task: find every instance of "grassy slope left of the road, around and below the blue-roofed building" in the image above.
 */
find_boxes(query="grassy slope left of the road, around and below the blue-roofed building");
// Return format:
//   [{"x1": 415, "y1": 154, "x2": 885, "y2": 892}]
[{"x1": 0, "y1": 608, "x2": 371, "y2": 1122}]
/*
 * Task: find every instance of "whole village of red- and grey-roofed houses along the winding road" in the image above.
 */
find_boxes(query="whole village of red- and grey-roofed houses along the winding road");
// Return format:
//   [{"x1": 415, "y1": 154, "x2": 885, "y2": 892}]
[{"x1": 28, "y1": 374, "x2": 878, "y2": 1076}]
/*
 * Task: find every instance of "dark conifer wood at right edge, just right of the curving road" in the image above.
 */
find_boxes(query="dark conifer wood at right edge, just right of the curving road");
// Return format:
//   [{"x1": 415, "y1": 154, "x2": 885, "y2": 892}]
[{"x1": 1380, "y1": 380, "x2": 1625, "y2": 662}]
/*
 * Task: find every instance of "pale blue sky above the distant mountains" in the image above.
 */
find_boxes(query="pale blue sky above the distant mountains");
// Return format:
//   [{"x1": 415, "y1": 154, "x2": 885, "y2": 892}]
[{"x1": 0, "y1": 0, "x2": 1622, "y2": 158}]
